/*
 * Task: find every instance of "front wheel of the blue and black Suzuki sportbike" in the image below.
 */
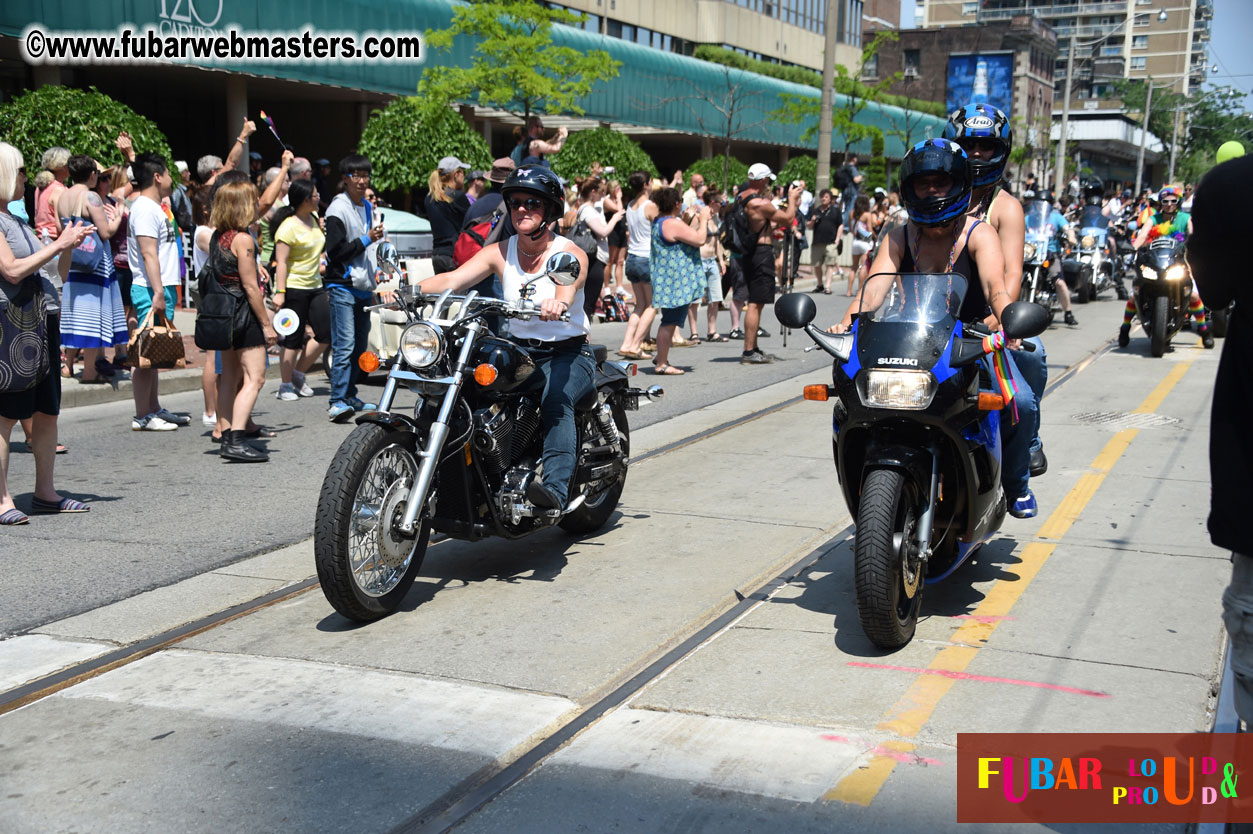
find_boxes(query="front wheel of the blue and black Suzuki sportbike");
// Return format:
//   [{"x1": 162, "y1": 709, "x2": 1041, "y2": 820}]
[{"x1": 853, "y1": 470, "x2": 923, "y2": 649}]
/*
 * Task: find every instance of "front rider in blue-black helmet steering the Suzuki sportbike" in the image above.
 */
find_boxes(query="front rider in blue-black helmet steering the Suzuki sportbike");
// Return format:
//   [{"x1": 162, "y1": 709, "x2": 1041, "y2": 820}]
[{"x1": 829, "y1": 139, "x2": 1036, "y2": 518}]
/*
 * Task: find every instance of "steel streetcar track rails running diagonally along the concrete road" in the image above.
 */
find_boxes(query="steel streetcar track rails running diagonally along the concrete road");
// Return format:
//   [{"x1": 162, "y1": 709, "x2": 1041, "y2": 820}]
[{"x1": 0, "y1": 341, "x2": 1114, "y2": 834}]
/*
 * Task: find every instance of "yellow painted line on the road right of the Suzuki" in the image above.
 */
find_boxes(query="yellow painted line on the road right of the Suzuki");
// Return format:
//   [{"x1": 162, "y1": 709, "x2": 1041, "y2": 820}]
[{"x1": 823, "y1": 362, "x2": 1192, "y2": 806}]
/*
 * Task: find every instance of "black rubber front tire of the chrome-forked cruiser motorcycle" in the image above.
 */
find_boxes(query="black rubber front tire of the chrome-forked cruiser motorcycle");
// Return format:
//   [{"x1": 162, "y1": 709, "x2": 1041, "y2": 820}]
[{"x1": 313, "y1": 423, "x2": 431, "y2": 622}]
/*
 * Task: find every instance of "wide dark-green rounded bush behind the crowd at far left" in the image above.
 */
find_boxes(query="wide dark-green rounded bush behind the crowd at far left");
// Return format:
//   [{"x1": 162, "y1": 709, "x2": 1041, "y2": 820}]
[{"x1": 0, "y1": 86, "x2": 174, "y2": 170}]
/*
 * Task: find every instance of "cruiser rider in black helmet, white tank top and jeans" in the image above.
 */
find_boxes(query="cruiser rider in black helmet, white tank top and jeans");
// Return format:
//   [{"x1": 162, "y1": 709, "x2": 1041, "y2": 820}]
[{"x1": 421, "y1": 165, "x2": 596, "y2": 510}]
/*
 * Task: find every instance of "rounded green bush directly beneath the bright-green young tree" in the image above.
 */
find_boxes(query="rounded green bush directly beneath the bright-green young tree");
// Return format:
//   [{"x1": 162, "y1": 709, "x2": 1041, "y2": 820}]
[{"x1": 357, "y1": 96, "x2": 491, "y2": 192}]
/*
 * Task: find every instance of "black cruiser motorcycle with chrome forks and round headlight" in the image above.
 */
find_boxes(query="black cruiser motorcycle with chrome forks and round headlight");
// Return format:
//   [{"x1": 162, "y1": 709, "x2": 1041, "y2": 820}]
[{"x1": 313, "y1": 243, "x2": 663, "y2": 621}]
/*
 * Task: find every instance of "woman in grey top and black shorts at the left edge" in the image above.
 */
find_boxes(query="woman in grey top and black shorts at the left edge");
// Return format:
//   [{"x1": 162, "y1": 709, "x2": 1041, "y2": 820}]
[{"x1": 0, "y1": 142, "x2": 95, "y2": 526}]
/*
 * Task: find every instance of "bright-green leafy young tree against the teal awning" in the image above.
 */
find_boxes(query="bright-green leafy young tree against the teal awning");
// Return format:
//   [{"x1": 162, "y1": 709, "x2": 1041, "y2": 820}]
[{"x1": 417, "y1": 0, "x2": 621, "y2": 118}]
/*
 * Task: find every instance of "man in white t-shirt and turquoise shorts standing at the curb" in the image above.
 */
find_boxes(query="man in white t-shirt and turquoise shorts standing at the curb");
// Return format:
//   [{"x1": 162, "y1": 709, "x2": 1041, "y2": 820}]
[{"x1": 127, "y1": 153, "x2": 192, "y2": 432}]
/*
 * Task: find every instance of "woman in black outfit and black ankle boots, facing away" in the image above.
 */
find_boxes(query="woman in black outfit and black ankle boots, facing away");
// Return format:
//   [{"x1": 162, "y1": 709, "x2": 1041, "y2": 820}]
[{"x1": 209, "y1": 182, "x2": 278, "y2": 463}]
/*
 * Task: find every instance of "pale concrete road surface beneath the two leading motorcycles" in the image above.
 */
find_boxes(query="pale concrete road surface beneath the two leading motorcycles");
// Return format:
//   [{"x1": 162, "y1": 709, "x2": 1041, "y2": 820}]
[{"x1": 0, "y1": 288, "x2": 1229, "y2": 834}]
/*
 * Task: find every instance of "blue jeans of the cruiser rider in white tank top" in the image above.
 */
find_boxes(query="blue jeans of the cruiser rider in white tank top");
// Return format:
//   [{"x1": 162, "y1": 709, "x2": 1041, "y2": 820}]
[{"x1": 526, "y1": 344, "x2": 596, "y2": 506}]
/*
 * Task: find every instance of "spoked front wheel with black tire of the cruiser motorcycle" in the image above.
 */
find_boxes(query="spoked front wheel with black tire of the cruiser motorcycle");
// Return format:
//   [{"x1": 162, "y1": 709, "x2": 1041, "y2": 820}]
[{"x1": 313, "y1": 423, "x2": 431, "y2": 622}]
